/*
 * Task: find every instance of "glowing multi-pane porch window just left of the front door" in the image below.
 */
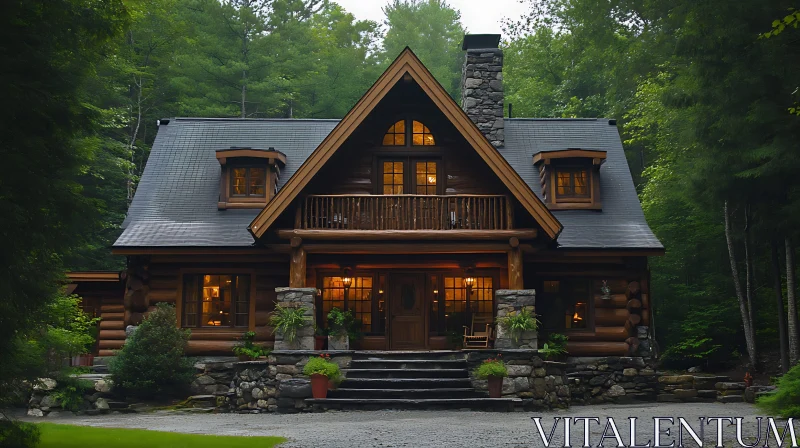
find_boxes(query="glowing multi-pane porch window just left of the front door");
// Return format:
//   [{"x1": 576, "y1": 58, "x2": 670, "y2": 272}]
[{"x1": 322, "y1": 276, "x2": 373, "y2": 333}]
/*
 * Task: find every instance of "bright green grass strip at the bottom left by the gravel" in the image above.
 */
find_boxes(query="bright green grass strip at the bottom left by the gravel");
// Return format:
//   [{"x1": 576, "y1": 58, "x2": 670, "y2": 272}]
[{"x1": 37, "y1": 423, "x2": 286, "y2": 448}]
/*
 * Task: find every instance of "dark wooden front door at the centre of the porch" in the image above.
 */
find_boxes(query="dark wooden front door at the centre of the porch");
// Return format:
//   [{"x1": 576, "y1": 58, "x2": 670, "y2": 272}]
[{"x1": 388, "y1": 274, "x2": 425, "y2": 350}]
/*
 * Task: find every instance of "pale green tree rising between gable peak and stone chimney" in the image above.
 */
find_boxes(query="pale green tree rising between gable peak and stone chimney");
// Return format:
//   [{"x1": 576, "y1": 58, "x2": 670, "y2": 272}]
[{"x1": 383, "y1": 0, "x2": 464, "y2": 101}]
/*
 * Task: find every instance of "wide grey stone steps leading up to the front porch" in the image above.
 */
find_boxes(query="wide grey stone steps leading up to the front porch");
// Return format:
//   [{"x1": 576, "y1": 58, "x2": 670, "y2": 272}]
[{"x1": 306, "y1": 351, "x2": 521, "y2": 411}]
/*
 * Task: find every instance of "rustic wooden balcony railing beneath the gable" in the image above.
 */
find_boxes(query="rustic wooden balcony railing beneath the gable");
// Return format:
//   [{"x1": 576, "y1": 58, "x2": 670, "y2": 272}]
[{"x1": 300, "y1": 194, "x2": 513, "y2": 230}]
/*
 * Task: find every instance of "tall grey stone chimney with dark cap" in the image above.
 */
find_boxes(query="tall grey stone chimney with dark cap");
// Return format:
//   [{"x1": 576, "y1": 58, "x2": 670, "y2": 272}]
[{"x1": 461, "y1": 34, "x2": 505, "y2": 148}]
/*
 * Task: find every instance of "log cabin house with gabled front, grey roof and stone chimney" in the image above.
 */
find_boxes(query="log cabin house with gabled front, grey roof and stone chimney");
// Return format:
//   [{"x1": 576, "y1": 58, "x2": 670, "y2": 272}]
[{"x1": 79, "y1": 35, "x2": 664, "y2": 356}]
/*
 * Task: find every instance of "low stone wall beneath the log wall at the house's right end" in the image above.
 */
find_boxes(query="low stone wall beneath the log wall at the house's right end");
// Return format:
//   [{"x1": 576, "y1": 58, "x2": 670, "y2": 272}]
[{"x1": 567, "y1": 356, "x2": 659, "y2": 404}]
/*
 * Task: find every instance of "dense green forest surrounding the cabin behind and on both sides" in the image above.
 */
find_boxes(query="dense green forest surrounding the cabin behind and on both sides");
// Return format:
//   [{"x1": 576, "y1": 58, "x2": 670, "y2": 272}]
[{"x1": 0, "y1": 0, "x2": 800, "y2": 390}]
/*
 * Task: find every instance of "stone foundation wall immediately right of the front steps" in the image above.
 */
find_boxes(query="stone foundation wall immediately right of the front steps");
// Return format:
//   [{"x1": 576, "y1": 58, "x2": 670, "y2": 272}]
[{"x1": 466, "y1": 350, "x2": 570, "y2": 410}]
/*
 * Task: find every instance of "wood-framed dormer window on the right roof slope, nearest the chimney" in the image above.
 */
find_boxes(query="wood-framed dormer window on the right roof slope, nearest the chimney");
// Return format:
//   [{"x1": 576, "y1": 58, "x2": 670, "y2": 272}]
[{"x1": 533, "y1": 149, "x2": 606, "y2": 210}]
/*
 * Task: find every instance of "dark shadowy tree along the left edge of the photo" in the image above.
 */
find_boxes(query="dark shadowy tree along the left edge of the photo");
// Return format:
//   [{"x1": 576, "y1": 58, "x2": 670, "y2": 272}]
[{"x1": 0, "y1": 0, "x2": 127, "y2": 399}]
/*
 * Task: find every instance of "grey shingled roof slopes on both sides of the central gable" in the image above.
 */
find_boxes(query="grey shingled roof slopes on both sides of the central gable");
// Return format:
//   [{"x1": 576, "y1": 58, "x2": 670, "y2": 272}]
[{"x1": 114, "y1": 118, "x2": 663, "y2": 249}]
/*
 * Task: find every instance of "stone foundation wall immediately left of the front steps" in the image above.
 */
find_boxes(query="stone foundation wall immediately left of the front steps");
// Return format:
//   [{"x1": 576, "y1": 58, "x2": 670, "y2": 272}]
[{"x1": 227, "y1": 350, "x2": 352, "y2": 413}]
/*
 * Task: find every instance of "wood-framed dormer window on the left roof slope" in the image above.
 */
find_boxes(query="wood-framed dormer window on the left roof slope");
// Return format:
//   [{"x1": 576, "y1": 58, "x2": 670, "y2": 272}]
[{"x1": 217, "y1": 147, "x2": 286, "y2": 210}]
